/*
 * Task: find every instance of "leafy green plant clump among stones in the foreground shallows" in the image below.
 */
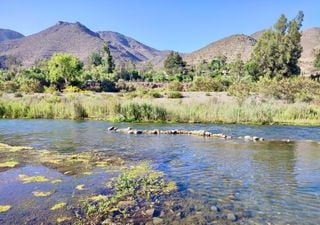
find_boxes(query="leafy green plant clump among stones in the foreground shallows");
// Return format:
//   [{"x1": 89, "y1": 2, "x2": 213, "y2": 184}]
[{"x1": 77, "y1": 162, "x2": 177, "y2": 224}]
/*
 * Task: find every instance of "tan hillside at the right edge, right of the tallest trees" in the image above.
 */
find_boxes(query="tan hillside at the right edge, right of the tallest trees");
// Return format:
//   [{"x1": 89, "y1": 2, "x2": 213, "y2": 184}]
[{"x1": 300, "y1": 27, "x2": 320, "y2": 75}]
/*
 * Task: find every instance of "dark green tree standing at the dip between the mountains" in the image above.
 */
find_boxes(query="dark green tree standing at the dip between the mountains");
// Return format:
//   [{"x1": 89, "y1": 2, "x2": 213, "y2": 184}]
[{"x1": 164, "y1": 51, "x2": 187, "y2": 76}]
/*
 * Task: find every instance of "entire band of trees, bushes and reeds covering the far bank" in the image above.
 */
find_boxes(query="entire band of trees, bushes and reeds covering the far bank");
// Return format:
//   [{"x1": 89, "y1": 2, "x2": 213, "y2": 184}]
[{"x1": 0, "y1": 12, "x2": 320, "y2": 124}]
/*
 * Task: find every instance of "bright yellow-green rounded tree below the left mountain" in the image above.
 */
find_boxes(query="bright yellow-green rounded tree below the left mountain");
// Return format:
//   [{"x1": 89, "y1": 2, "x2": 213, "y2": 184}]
[{"x1": 48, "y1": 53, "x2": 83, "y2": 90}]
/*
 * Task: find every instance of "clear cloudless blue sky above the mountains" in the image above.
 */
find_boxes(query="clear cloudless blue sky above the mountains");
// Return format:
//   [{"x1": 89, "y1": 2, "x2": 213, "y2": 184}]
[{"x1": 0, "y1": 0, "x2": 320, "y2": 52}]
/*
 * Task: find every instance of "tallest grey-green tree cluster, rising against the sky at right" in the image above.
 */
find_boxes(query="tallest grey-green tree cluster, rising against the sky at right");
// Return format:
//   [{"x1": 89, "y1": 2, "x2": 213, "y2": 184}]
[{"x1": 249, "y1": 11, "x2": 303, "y2": 79}]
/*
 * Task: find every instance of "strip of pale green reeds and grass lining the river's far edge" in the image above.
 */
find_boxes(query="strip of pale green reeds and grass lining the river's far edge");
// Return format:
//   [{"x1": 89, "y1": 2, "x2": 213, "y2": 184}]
[{"x1": 0, "y1": 92, "x2": 320, "y2": 125}]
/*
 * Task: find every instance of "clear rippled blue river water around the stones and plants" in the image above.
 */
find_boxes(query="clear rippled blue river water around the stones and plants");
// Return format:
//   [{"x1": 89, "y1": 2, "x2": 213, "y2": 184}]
[{"x1": 0, "y1": 120, "x2": 320, "y2": 224}]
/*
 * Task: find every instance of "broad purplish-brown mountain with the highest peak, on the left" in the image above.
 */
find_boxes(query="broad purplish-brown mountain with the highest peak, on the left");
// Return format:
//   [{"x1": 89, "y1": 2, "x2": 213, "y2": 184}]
[{"x1": 0, "y1": 21, "x2": 166, "y2": 66}]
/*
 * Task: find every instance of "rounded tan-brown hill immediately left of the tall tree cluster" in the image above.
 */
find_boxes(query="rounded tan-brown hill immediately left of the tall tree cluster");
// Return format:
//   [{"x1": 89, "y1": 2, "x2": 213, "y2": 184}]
[{"x1": 184, "y1": 34, "x2": 257, "y2": 65}]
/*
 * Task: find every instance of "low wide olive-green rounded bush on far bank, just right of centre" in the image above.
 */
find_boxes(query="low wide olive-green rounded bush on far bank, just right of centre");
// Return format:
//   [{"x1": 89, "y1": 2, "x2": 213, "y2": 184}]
[{"x1": 191, "y1": 77, "x2": 224, "y2": 92}]
